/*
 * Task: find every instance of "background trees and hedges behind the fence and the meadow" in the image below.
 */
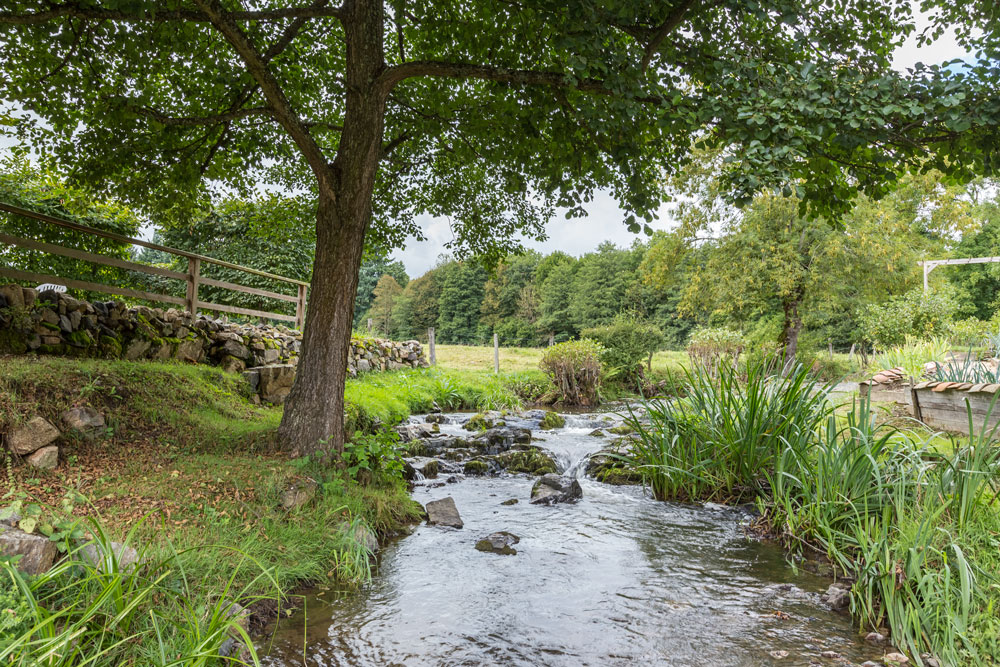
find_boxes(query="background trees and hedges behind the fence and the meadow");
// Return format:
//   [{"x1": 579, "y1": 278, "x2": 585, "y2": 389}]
[{"x1": 0, "y1": 151, "x2": 1000, "y2": 368}]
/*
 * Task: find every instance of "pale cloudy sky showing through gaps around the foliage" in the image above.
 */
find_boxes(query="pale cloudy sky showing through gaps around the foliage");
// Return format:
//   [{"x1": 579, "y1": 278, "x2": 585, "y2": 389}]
[{"x1": 392, "y1": 2, "x2": 968, "y2": 277}]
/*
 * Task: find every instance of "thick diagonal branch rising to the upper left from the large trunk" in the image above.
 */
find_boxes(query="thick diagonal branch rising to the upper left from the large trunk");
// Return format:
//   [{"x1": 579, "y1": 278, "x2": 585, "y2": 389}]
[{"x1": 195, "y1": 0, "x2": 336, "y2": 199}]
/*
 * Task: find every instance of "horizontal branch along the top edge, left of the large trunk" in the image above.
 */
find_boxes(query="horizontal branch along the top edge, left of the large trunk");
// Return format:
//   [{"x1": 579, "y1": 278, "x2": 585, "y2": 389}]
[{"x1": 0, "y1": 2, "x2": 344, "y2": 25}]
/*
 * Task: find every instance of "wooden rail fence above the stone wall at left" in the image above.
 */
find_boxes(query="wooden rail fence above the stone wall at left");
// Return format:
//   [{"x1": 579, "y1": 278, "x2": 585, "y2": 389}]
[{"x1": 0, "y1": 202, "x2": 309, "y2": 329}]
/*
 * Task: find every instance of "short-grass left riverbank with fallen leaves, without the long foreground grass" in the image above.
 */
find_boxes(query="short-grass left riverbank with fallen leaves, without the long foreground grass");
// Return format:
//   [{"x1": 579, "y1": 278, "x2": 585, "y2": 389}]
[{"x1": 0, "y1": 357, "x2": 539, "y2": 664}]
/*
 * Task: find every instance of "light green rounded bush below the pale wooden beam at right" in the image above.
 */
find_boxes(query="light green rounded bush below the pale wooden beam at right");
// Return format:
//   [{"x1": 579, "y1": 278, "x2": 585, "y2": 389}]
[{"x1": 858, "y1": 288, "x2": 958, "y2": 350}]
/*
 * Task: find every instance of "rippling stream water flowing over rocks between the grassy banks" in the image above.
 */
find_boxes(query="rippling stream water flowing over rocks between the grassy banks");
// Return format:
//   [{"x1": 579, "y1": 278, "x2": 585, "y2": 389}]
[{"x1": 261, "y1": 415, "x2": 880, "y2": 667}]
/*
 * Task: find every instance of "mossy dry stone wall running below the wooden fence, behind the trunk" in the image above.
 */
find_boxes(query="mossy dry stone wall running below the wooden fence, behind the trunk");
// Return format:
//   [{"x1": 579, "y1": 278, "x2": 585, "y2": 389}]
[{"x1": 0, "y1": 285, "x2": 427, "y2": 403}]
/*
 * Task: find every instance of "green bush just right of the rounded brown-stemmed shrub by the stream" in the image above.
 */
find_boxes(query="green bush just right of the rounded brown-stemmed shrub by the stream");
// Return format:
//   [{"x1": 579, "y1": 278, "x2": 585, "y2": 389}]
[{"x1": 580, "y1": 314, "x2": 664, "y2": 385}]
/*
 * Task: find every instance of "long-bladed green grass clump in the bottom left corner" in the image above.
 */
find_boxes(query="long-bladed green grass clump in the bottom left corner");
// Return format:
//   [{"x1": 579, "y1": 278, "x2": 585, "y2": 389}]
[{"x1": 0, "y1": 520, "x2": 277, "y2": 667}]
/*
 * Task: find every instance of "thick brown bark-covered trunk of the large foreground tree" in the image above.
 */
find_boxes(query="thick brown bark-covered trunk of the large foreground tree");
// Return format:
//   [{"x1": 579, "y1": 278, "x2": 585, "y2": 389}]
[{"x1": 278, "y1": 0, "x2": 387, "y2": 456}]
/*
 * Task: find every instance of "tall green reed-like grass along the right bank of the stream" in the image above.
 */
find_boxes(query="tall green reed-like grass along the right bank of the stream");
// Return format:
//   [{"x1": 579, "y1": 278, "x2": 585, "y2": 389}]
[{"x1": 630, "y1": 365, "x2": 1000, "y2": 665}]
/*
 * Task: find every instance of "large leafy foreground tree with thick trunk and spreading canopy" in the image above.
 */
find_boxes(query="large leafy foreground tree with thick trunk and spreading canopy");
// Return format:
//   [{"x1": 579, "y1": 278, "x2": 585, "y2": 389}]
[{"x1": 0, "y1": 0, "x2": 998, "y2": 451}]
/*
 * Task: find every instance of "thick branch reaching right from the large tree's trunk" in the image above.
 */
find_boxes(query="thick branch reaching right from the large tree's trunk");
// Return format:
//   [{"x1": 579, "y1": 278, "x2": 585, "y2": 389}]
[{"x1": 378, "y1": 60, "x2": 663, "y2": 104}]
